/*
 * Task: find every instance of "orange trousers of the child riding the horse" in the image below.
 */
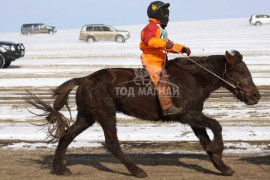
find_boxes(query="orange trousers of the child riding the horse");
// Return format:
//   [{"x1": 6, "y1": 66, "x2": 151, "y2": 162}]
[{"x1": 141, "y1": 54, "x2": 173, "y2": 110}]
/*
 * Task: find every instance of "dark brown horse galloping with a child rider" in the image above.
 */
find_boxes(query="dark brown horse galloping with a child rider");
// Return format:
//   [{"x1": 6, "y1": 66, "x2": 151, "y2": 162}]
[{"x1": 27, "y1": 51, "x2": 260, "y2": 177}]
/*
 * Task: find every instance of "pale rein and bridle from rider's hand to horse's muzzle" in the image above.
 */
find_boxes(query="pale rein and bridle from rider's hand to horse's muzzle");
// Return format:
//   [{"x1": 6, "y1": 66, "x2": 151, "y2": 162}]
[{"x1": 173, "y1": 49, "x2": 246, "y2": 94}]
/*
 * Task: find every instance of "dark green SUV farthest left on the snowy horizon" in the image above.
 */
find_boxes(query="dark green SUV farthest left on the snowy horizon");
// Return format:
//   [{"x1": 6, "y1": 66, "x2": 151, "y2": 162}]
[{"x1": 21, "y1": 23, "x2": 57, "y2": 35}]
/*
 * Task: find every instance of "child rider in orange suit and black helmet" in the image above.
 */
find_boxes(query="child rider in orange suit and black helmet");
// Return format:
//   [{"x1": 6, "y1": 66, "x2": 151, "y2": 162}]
[{"x1": 140, "y1": 1, "x2": 191, "y2": 116}]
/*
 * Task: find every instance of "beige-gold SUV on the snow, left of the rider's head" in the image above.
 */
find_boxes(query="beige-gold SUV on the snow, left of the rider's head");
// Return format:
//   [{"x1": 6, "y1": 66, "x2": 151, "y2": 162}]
[{"x1": 80, "y1": 24, "x2": 130, "y2": 43}]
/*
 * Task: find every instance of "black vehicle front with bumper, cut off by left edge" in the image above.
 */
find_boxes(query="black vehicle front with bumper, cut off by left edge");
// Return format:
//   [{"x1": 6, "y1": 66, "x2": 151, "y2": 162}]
[{"x1": 0, "y1": 41, "x2": 25, "y2": 68}]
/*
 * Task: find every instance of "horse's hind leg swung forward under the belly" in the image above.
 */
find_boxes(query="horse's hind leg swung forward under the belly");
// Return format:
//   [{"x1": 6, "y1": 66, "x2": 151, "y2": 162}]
[{"x1": 98, "y1": 115, "x2": 147, "y2": 178}]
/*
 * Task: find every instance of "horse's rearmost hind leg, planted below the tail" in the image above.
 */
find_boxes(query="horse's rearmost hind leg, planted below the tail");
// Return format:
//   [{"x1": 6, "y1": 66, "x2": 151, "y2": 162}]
[{"x1": 53, "y1": 114, "x2": 94, "y2": 175}]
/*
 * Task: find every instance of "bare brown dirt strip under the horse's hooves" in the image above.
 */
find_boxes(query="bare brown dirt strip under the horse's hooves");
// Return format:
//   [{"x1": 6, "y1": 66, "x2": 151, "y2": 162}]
[{"x1": 0, "y1": 143, "x2": 270, "y2": 180}]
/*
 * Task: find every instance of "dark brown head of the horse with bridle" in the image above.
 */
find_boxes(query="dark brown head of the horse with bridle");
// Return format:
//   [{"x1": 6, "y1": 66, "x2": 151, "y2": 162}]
[{"x1": 223, "y1": 51, "x2": 261, "y2": 105}]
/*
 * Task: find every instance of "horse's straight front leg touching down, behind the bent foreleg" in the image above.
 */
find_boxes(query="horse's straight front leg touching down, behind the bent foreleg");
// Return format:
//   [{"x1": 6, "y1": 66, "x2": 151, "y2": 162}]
[{"x1": 191, "y1": 126, "x2": 234, "y2": 175}]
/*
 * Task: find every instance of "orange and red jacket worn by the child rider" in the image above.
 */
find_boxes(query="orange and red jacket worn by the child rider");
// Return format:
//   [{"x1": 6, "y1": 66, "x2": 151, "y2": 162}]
[{"x1": 140, "y1": 18, "x2": 184, "y2": 61}]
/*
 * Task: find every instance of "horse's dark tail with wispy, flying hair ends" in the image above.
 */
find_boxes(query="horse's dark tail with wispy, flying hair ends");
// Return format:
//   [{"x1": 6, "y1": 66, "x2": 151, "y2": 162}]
[{"x1": 25, "y1": 78, "x2": 82, "y2": 142}]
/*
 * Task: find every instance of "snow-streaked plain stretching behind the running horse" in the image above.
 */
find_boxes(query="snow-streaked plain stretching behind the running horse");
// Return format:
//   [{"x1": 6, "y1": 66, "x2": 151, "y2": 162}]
[{"x1": 0, "y1": 19, "x2": 270, "y2": 152}]
